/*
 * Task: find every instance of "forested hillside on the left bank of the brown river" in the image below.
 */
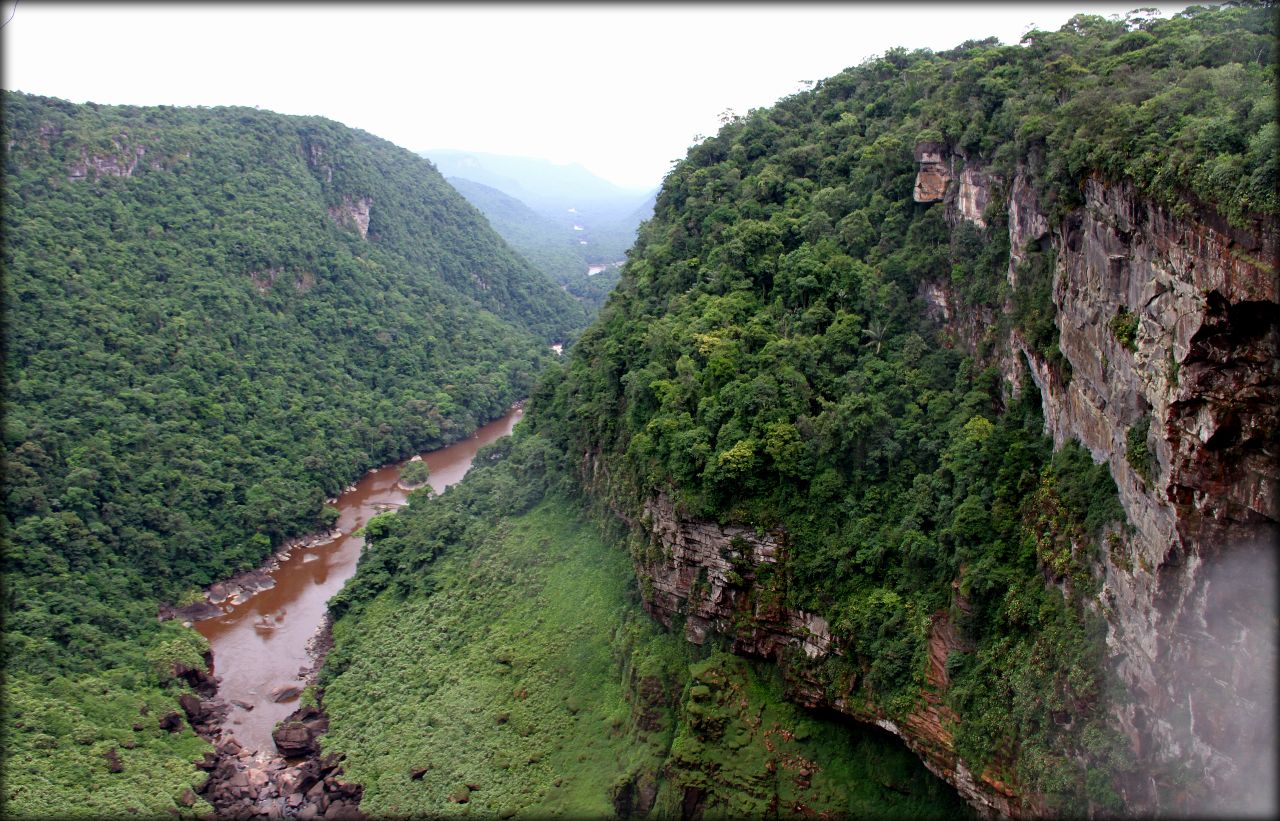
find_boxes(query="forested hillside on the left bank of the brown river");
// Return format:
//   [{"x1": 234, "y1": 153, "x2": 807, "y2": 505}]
[{"x1": 3, "y1": 92, "x2": 585, "y2": 817}]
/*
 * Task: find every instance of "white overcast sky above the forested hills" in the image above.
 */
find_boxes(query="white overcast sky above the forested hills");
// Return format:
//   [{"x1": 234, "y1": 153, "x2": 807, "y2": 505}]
[{"x1": 0, "y1": 0, "x2": 1187, "y2": 187}]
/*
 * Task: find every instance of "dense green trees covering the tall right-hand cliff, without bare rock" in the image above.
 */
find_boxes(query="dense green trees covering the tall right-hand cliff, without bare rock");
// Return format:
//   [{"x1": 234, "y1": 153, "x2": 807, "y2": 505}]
[{"x1": 519, "y1": 6, "x2": 1277, "y2": 809}]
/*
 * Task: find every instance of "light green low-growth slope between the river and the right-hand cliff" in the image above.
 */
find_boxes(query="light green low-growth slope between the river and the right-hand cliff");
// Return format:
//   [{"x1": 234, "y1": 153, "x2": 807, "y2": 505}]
[{"x1": 323, "y1": 429, "x2": 965, "y2": 818}]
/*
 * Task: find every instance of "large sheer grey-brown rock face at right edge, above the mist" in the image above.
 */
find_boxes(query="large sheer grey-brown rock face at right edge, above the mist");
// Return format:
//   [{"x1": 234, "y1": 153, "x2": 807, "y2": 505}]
[{"x1": 934, "y1": 154, "x2": 1280, "y2": 811}]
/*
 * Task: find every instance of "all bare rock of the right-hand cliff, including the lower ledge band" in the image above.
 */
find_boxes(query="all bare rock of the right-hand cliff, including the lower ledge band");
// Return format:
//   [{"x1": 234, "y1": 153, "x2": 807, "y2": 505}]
[{"x1": 604, "y1": 156, "x2": 1280, "y2": 816}]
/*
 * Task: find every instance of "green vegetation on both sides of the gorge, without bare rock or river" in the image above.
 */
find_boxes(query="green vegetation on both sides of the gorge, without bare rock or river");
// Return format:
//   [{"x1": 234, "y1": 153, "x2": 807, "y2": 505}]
[{"x1": 0, "y1": 4, "x2": 1280, "y2": 817}]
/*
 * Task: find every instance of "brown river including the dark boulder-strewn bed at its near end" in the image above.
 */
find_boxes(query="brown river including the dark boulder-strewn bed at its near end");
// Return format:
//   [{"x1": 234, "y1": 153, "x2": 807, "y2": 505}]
[{"x1": 163, "y1": 405, "x2": 524, "y2": 821}]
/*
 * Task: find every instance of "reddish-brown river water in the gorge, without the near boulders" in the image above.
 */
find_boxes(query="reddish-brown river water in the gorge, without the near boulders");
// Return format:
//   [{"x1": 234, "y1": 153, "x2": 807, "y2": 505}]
[{"x1": 195, "y1": 407, "x2": 524, "y2": 752}]
